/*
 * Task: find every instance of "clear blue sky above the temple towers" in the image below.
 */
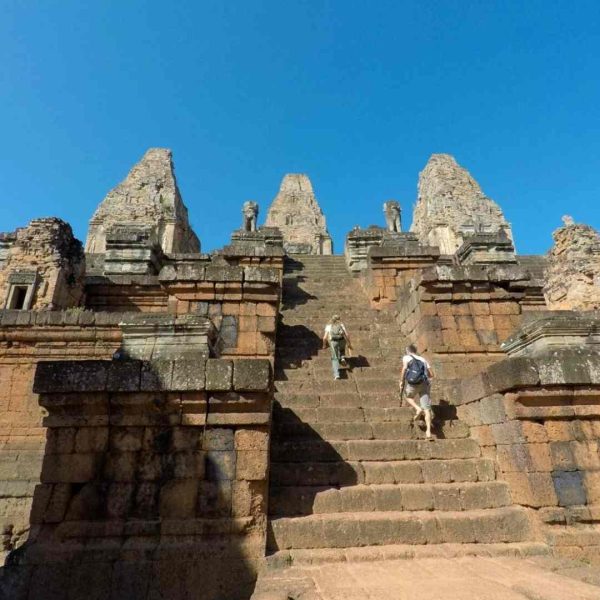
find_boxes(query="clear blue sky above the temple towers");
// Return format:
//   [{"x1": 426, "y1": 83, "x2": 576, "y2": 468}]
[{"x1": 0, "y1": 0, "x2": 600, "y2": 254}]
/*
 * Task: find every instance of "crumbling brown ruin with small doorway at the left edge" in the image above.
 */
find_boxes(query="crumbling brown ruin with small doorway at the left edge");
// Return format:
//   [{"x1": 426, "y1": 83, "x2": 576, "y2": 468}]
[{"x1": 0, "y1": 218, "x2": 85, "y2": 310}]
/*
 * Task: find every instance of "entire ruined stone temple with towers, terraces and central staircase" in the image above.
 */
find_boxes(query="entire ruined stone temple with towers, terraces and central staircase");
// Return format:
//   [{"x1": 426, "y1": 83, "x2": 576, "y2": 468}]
[{"x1": 0, "y1": 149, "x2": 600, "y2": 600}]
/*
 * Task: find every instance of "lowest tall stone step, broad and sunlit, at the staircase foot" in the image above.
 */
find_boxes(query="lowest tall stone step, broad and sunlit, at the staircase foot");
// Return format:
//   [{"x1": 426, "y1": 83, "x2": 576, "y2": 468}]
[{"x1": 267, "y1": 506, "x2": 531, "y2": 551}]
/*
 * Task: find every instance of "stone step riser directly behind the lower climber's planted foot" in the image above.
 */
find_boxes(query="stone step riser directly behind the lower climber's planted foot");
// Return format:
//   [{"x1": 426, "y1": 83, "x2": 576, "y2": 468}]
[{"x1": 273, "y1": 419, "x2": 470, "y2": 441}]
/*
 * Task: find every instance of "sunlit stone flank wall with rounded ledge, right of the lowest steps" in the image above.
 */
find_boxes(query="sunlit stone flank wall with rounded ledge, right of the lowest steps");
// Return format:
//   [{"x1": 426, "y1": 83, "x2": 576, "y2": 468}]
[{"x1": 454, "y1": 347, "x2": 600, "y2": 564}]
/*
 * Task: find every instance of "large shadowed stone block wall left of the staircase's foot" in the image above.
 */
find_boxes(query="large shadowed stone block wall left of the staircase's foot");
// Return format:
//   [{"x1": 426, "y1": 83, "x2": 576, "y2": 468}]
[{"x1": 2, "y1": 359, "x2": 271, "y2": 600}]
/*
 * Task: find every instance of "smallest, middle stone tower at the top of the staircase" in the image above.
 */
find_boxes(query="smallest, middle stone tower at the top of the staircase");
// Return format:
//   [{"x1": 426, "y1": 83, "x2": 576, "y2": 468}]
[{"x1": 266, "y1": 173, "x2": 333, "y2": 254}]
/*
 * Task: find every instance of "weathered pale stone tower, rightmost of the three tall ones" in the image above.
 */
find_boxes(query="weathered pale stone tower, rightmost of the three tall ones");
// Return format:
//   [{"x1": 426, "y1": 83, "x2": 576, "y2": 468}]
[{"x1": 410, "y1": 154, "x2": 512, "y2": 254}]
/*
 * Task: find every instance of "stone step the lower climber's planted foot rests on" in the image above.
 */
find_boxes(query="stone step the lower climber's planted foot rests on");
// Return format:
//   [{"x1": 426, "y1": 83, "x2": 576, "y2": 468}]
[{"x1": 271, "y1": 438, "x2": 481, "y2": 462}]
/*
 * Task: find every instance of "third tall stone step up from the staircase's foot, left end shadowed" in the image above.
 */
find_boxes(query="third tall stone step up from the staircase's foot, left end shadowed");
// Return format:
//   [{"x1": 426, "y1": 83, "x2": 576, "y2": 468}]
[{"x1": 270, "y1": 458, "x2": 496, "y2": 486}]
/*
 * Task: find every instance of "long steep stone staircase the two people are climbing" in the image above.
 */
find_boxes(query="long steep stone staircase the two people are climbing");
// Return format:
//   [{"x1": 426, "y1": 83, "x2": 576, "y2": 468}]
[{"x1": 268, "y1": 256, "x2": 543, "y2": 564}]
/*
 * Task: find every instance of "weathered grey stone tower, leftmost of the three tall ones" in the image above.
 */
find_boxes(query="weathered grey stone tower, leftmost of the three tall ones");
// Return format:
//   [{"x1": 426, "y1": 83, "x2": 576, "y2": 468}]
[{"x1": 85, "y1": 148, "x2": 200, "y2": 254}]
